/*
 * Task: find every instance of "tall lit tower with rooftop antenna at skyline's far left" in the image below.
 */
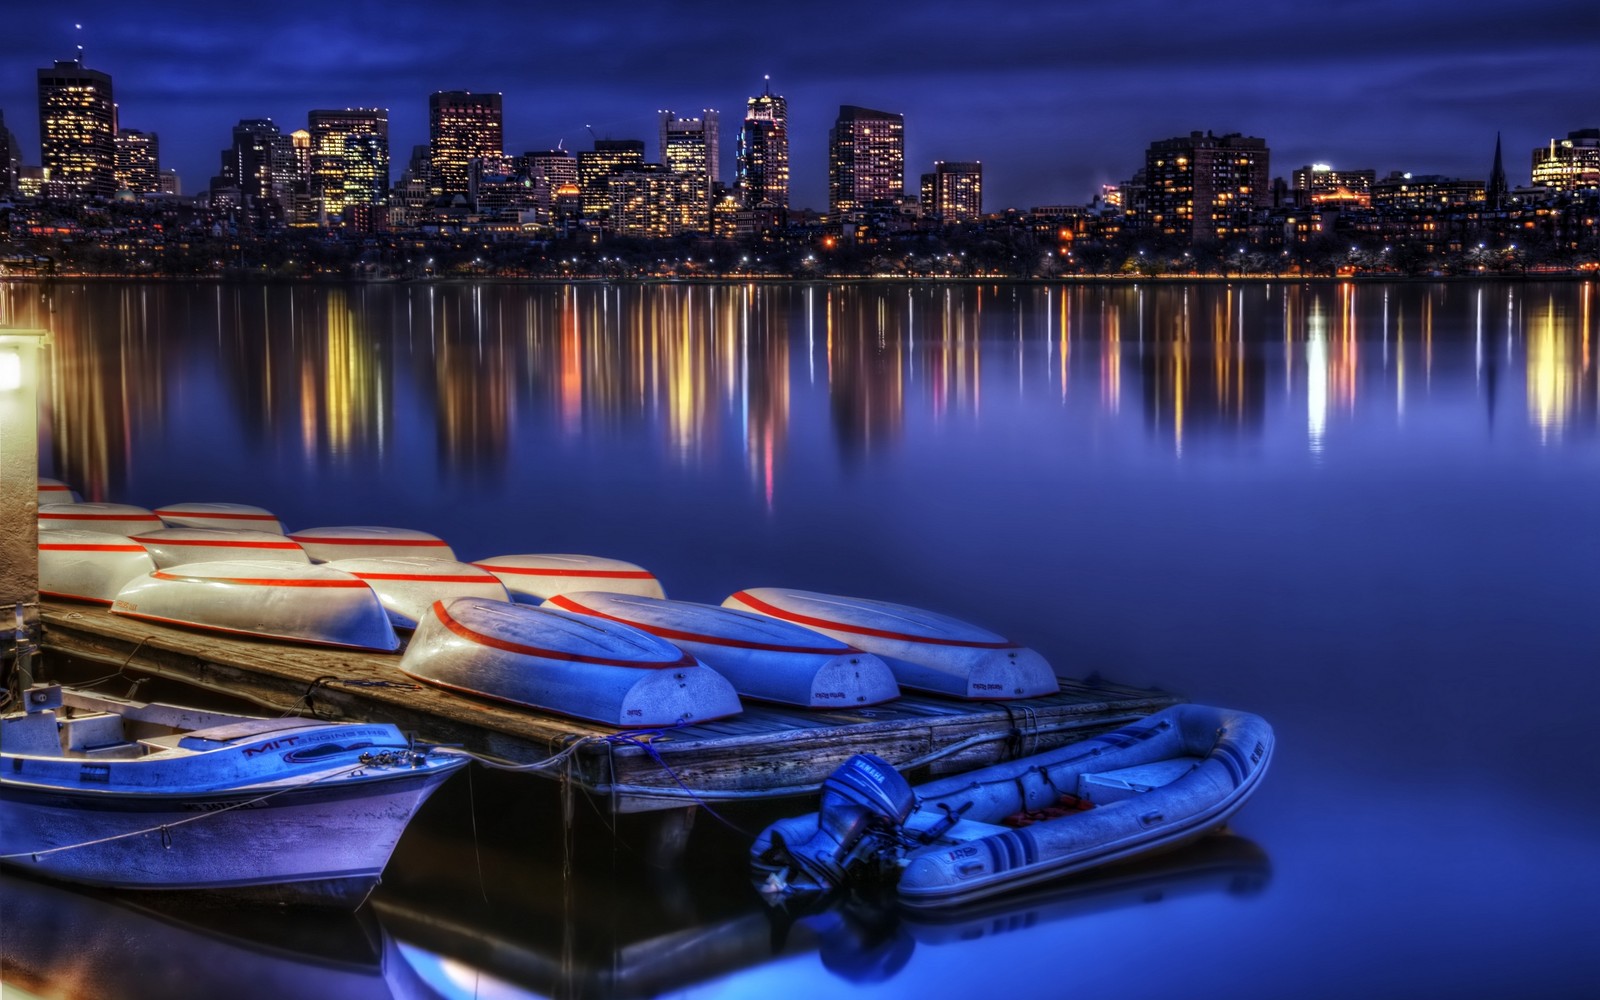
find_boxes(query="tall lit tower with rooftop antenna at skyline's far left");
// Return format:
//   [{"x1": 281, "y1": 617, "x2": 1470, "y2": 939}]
[{"x1": 38, "y1": 58, "x2": 117, "y2": 198}]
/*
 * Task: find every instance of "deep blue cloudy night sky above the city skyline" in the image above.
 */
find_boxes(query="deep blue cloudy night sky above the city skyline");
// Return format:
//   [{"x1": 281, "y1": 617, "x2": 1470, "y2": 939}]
[{"x1": 0, "y1": 0, "x2": 1600, "y2": 210}]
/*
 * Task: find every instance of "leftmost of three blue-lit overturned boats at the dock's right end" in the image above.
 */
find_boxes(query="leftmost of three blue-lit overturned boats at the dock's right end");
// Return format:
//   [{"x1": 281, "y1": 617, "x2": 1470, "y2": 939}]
[{"x1": 400, "y1": 597, "x2": 742, "y2": 728}]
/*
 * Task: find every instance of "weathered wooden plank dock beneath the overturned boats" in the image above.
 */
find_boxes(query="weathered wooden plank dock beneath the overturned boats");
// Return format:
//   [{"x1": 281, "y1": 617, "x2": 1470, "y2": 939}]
[{"x1": 40, "y1": 600, "x2": 1182, "y2": 813}]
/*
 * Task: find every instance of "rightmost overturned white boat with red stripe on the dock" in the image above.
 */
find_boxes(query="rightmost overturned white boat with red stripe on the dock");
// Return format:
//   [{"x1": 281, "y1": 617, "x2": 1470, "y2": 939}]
[{"x1": 722, "y1": 587, "x2": 1061, "y2": 701}]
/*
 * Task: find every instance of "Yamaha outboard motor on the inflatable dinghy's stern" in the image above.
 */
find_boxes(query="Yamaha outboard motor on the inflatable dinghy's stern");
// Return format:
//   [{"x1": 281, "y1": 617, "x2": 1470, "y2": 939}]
[{"x1": 758, "y1": 754, "x2": 917, "y2": 893}]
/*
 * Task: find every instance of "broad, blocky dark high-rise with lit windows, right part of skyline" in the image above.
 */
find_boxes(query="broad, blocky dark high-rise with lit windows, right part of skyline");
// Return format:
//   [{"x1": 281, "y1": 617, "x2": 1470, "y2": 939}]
[{"x1": 1136, "y1": 131, "x2": 1272, "y2": 242}]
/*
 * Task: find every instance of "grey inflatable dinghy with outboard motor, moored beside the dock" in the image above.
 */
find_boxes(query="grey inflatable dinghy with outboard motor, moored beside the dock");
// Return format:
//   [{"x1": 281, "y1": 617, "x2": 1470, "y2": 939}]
[{"x1": 750, "y1": 704, "x2": 1274, "y2": 907}]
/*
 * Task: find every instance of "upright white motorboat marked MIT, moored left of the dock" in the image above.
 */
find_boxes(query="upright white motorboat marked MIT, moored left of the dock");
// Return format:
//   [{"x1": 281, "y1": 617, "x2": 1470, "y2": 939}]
[{"x1": 0, "y1": 686, "x2": 469, "y2": 909}]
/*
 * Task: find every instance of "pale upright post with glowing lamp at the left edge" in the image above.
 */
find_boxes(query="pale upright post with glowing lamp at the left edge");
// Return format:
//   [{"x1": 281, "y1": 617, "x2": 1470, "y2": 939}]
[{"x1": 0, "y1": 326, "x2": 50, "y2": 691}]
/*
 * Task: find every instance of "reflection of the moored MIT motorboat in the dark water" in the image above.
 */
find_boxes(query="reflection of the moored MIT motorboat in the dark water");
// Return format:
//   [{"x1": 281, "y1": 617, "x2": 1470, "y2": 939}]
[{"x1": 0, "y1": 872, "x2": 427, "y2": 1000}]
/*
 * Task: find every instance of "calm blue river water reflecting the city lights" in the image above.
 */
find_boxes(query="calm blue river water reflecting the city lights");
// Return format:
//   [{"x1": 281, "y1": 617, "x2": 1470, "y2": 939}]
[{"x1": 0, "y1": 283, "x2": 1600, "y2": 998}]
